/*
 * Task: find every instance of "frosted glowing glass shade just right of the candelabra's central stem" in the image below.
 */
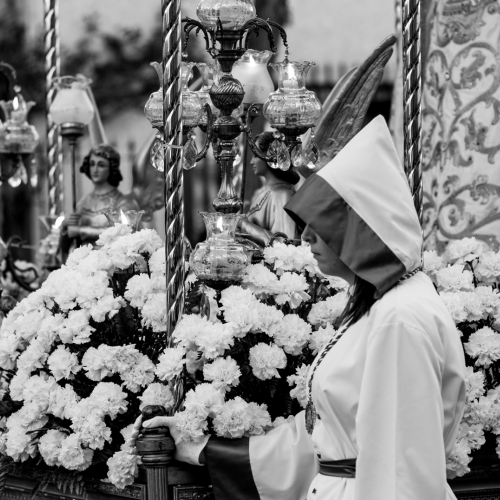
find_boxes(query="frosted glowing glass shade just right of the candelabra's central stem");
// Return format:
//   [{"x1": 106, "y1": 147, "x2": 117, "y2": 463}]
[{"x1": 233, "y1": 49, "x2": 274, "y2": 104}]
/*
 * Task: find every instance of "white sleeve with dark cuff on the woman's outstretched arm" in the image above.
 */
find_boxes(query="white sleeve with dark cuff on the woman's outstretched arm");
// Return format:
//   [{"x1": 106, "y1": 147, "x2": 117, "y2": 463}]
[{"x1": 205, "y1": 412, "x2": 318, "y2": 500}]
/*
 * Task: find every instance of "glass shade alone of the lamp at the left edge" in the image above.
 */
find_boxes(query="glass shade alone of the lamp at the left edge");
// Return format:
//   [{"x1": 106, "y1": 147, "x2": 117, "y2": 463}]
[{"x1": 0, "y1": 92, "x2": 39, "y2": 155}]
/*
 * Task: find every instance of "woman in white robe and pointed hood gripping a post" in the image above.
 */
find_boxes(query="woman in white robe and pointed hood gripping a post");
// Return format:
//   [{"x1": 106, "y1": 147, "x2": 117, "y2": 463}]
[{"x1": 131, "y1": 117, "x2": 465, "y2": 500}]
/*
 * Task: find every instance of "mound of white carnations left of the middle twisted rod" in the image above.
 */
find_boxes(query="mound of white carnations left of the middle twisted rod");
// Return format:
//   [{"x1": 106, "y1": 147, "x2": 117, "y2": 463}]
[{"x1": 0, "y1": 225, "x2": 178, "y2": 487}]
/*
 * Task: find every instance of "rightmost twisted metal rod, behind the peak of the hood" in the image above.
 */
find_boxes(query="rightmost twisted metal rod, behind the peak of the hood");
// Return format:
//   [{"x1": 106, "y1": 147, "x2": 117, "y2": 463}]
[{"x1": 401, "y1": 0, "x2": 423, "y2": 223}]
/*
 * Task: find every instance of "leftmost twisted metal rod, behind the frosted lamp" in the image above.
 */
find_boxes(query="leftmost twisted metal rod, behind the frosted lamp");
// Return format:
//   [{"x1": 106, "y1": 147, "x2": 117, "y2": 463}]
[{"x1": 43, "y1": 0, "x2": 63, "y2": 215}]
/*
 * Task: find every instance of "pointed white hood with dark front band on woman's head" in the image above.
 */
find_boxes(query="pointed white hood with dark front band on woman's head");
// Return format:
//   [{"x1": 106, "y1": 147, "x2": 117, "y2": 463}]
[{"x1": 285, "y1": 116, "x2": 422, "y2": 295}]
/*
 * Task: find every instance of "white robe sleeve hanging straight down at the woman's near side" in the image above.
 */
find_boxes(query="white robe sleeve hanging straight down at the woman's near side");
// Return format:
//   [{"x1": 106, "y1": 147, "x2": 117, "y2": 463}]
[{"x1": 354, "y1": 322, "x2": 456, "y2": 500}]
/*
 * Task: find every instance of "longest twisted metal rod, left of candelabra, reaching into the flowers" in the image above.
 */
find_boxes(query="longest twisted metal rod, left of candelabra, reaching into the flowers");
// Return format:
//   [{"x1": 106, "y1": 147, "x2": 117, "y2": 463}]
[{"x1": 161, "y1": 0, "x2": 185, "y2": 344}]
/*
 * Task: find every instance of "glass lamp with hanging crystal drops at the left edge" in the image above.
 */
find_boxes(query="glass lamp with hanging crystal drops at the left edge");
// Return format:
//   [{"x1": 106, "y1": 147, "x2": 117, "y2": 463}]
[{"x1": 0, "y1": 87, "x2": 39, "y2": 187}]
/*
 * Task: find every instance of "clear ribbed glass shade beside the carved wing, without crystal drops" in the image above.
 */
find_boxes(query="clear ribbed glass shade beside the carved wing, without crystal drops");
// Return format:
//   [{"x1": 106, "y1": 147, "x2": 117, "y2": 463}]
[{"x1": 263, "y1": 61, "x2": 322, "y2": 129}]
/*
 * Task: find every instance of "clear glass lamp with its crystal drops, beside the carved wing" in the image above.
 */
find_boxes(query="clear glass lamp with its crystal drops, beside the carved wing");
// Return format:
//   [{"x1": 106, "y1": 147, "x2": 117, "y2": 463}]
[{"x1": 263, "y1": 59, "x2": 322, "y2": 168}]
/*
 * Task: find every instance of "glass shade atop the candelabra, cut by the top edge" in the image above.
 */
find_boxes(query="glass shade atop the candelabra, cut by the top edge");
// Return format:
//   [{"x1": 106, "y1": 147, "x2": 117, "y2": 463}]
[{"x1": 196, "y1": 0, "x2": 255, "y2": 31}]
